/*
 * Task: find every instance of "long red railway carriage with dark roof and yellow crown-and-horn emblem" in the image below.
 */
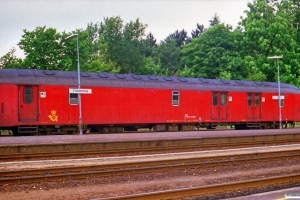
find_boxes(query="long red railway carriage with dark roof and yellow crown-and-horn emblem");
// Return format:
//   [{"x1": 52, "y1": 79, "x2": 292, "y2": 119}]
[{"x1": 0, "y1": 69, "x2": 300, "y2": 135}]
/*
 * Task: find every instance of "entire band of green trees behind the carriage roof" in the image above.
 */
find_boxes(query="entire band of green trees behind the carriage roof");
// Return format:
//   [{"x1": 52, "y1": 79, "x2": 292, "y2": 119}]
[{"x1": 0, "y1": 0, "x2": 300, "y2": 87}]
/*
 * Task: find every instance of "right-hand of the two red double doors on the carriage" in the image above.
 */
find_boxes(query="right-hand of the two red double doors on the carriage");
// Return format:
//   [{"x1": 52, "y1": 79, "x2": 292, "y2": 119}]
[{"x1": 247, "y1": 93, "x2": 261, "y2": 119}]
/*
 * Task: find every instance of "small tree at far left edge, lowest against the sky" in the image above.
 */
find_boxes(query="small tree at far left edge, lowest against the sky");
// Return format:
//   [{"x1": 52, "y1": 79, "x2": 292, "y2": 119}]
[{"x1": 0, "y1": 48, "x2": 22, "y2": 69}]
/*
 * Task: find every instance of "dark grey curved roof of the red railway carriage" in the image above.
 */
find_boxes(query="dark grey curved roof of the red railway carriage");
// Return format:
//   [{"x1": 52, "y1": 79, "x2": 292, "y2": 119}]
[{"x1": 0, "y1": 69, "x2": 299, "y2": 93}]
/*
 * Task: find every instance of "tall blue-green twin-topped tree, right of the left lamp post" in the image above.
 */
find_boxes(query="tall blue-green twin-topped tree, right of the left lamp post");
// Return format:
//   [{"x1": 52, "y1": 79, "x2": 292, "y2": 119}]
[{"x1": 99, "y1": 16, "x2": 147, "y2": 73}]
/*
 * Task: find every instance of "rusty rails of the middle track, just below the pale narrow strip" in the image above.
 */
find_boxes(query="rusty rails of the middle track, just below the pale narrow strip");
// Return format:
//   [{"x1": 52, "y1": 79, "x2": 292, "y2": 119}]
[{"x1": 0, "y1": 150, "x2": 300, "y2": 185}]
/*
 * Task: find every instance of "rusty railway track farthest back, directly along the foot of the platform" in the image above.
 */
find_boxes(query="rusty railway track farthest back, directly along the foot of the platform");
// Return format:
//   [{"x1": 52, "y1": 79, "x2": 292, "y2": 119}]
[{"x1": 0, "y1": 139, "x2": 300, "y2": 162}]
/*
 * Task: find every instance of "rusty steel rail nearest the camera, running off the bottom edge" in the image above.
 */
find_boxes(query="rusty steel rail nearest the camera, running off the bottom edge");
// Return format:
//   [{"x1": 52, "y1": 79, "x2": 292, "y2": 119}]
[{"x1": 95, "y1": 174, "x2": 300, "y2": 200}]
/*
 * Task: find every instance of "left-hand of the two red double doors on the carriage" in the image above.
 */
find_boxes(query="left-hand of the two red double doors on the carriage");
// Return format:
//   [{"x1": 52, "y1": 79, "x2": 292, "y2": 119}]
[{"x1": 212, "y1": 92, "x2": 227, "y2": 119}]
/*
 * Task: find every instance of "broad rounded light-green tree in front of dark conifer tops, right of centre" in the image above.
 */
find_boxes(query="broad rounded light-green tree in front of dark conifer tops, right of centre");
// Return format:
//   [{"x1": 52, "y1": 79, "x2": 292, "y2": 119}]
[{"x1": 181, "y1": 24, "x2": 244, "y2": 79}]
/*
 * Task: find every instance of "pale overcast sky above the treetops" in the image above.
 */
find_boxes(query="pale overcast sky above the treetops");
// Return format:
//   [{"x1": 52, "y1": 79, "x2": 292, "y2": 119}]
[{"x1": 0, "y1": 0, "x2": 252, "y2": 57}]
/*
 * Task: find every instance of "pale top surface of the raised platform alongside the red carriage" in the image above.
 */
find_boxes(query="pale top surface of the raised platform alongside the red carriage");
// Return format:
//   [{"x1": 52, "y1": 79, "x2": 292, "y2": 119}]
[{"x1": 0, "y1": 128, "x2": 300, "y2": 146}]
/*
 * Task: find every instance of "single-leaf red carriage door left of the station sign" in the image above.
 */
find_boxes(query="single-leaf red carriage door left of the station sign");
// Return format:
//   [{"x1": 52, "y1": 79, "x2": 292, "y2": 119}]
[{"x1": 19, "y1": 86, "x2": 38, "y2": 121}]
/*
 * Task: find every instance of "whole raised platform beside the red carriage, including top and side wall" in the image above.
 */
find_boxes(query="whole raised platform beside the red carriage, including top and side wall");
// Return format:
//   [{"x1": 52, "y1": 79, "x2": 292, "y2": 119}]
[{"x1": 0, "y1": 129, "x2": 300, "y2": 155}]
